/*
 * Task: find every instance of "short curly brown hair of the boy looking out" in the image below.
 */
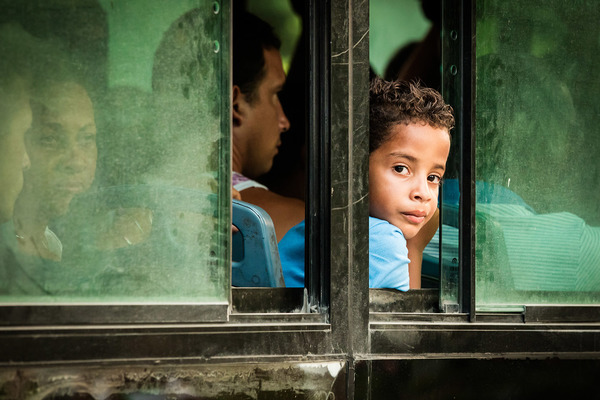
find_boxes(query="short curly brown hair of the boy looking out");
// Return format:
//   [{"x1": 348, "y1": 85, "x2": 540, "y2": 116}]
[{"x1": 369, "y1": 77, "x2": 454, "y2": 153}]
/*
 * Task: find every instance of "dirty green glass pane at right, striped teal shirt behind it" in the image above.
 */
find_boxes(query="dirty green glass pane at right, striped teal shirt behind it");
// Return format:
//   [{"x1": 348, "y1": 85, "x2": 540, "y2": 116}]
[{"x1": 476, "y1": 0, "x2": 600, "y2": 310}]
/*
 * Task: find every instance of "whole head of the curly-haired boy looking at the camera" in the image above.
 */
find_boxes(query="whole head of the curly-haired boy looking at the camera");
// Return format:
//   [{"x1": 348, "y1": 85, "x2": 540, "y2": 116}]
[{"x1": 369, "y1": 78, "x2": 454, "y2": 239}]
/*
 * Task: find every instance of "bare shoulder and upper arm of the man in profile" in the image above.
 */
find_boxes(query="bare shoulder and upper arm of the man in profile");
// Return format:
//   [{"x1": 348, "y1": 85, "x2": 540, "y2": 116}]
[{"x1": 240, "y1": 187, "x2": 305, "y2": 241}]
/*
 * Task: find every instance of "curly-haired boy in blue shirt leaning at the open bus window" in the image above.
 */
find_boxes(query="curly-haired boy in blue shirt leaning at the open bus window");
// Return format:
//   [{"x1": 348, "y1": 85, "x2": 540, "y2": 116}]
[{"x1": 280, "y1": 78, "x2": 454, "y2": 291}]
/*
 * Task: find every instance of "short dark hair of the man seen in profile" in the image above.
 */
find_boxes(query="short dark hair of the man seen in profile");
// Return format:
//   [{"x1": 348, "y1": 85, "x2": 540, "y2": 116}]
[{"x1": 233, "y1": 11, "x2": 281, "y2": 103}]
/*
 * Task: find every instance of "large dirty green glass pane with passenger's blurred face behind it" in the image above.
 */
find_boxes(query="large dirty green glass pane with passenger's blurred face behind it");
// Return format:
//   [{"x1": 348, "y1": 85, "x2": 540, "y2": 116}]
[{"x1": 0, "y1": 0, "x2": 231, "y2": 304}]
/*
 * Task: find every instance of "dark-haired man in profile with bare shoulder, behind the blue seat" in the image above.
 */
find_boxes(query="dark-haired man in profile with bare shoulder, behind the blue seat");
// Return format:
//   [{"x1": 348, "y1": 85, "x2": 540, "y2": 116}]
[{"x1": 232, "y1": 12, "x2": 304, "y2": 241}]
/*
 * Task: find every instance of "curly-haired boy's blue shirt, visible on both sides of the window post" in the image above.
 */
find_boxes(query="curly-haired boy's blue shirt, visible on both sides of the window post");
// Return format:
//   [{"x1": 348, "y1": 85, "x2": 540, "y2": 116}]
[{"x1": 279, "y1": 217, "x2": 409, "y2": 291}]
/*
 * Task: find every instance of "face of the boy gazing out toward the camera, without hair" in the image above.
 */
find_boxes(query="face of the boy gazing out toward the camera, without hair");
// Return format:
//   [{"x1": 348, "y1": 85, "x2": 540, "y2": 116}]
[{"x1": 369, "y1": 123, "x2": 450, "y2": 239}]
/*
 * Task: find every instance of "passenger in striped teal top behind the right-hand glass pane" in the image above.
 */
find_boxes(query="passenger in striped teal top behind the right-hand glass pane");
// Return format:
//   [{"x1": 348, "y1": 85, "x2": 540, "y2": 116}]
[{"x1": 425, "y1": 179, "x2": 600, "y2": 293}]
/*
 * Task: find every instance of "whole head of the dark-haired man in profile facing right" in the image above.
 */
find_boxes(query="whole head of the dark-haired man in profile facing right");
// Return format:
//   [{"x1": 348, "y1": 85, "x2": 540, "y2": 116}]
[{"x1": 232, "y1": 13, "x2": 290, "y2": 178}]
